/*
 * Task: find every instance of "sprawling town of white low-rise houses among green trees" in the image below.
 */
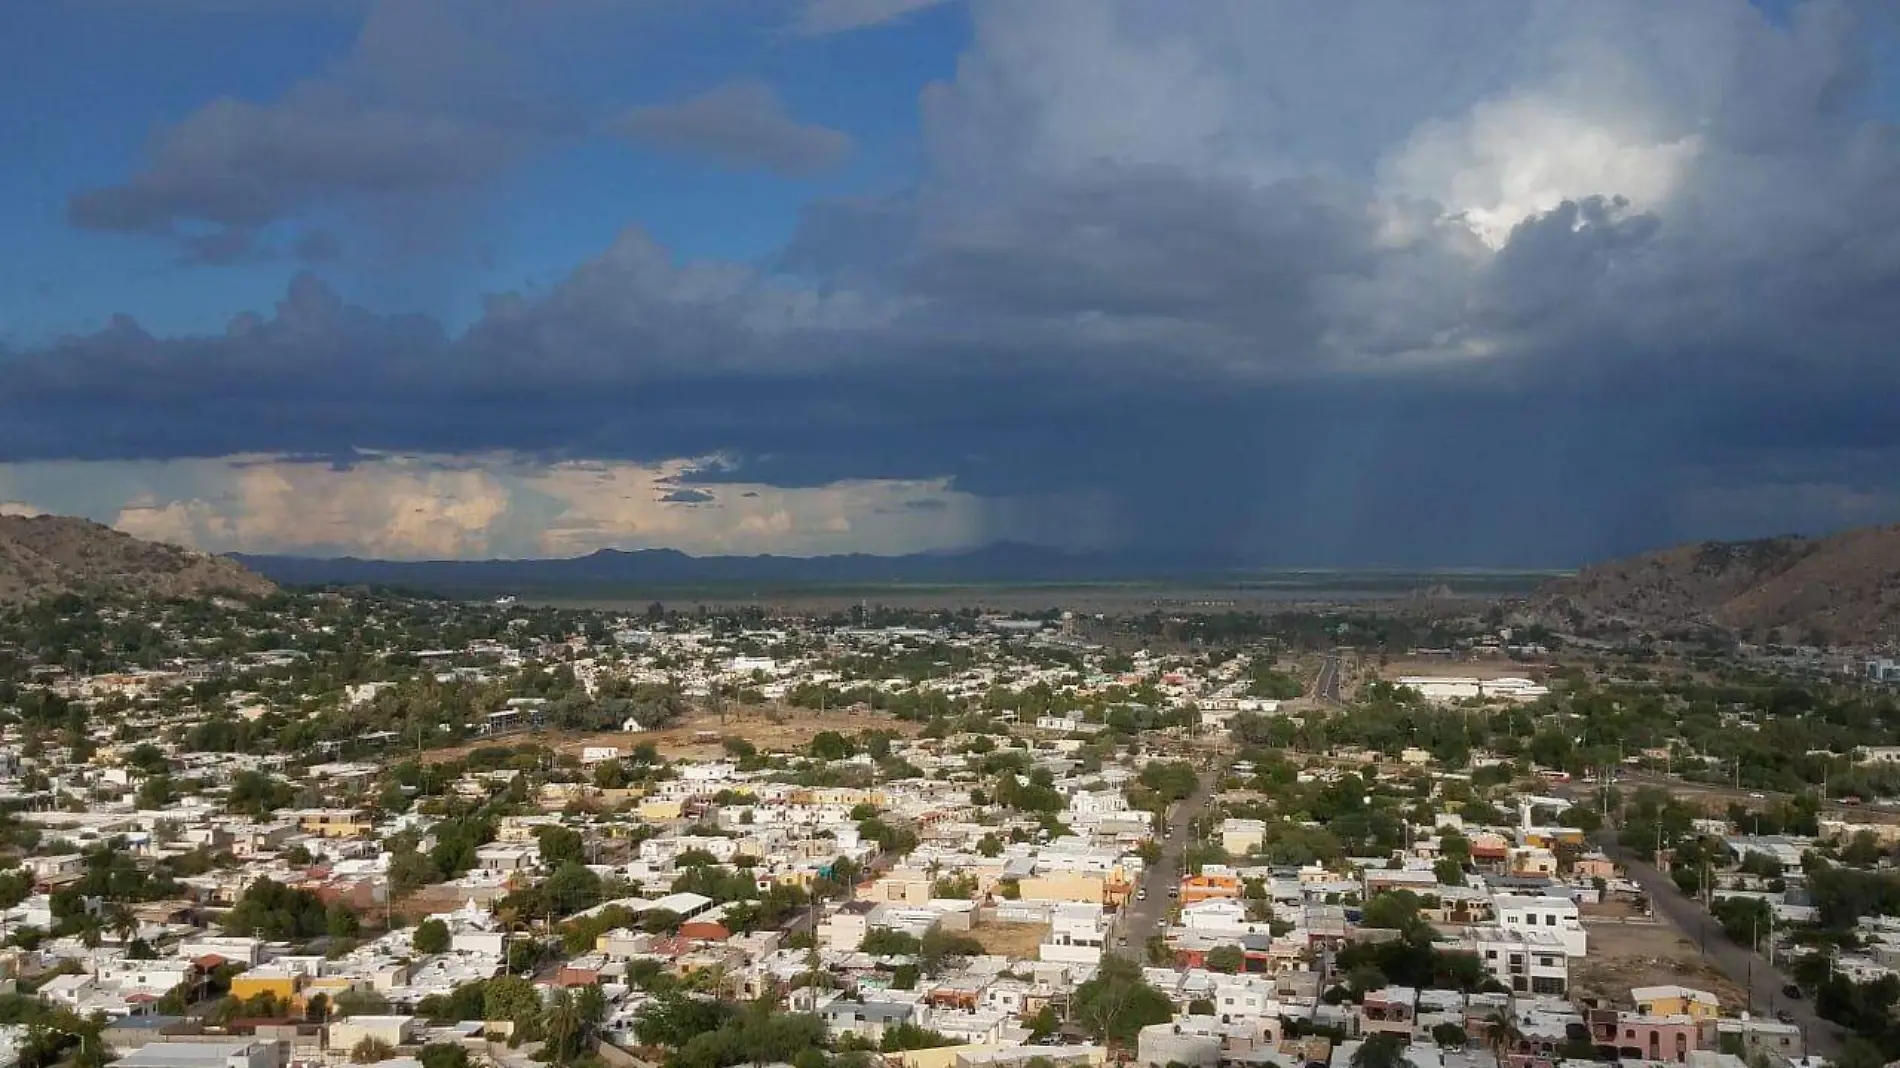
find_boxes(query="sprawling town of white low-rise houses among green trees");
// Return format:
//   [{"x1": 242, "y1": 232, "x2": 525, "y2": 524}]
[{"x1": 0, "y1": 591, "x2": 1900, "y2": 1068}]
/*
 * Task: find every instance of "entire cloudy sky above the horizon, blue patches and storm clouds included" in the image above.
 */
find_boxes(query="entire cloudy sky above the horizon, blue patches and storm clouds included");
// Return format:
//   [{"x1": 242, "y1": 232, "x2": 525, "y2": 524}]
[{"x1": 0, "y1": 0, "x2": 1900, "y2": 566}]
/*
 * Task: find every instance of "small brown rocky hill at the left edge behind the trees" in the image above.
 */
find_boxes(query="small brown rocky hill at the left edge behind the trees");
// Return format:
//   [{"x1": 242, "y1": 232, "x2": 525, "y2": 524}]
[{"x1": 0, "y1": 515, "x2": 277, "y2": 604}]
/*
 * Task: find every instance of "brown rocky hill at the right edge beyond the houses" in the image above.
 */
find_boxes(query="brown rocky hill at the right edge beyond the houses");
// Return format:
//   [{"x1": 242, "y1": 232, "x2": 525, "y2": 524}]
[{"x1": 1528, "y1": 526, "x2": 1900, "y2": 644}]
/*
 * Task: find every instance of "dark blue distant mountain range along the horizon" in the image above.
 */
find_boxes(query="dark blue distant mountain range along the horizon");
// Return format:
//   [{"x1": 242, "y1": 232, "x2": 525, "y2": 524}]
[{"x1": 234, "y1": 544, "x2": 1241, "y2": 593}]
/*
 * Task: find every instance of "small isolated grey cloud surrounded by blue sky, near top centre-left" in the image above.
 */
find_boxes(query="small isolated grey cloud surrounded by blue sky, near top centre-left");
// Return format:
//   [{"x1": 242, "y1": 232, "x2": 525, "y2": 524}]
[{"x1": 608, "y1": 82, "x2": 851, "y2": 177}]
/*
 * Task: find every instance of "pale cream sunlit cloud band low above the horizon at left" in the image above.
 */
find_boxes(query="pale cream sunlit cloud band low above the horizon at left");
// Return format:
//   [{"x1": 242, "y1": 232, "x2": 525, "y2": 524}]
[{"x1": 0, "y1": 454, "x2": 1007, "y2": 559}]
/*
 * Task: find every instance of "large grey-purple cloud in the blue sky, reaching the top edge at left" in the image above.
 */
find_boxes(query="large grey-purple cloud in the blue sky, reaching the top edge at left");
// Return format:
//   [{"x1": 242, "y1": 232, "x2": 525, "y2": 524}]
[{"x1": 67, "y1": 0, "x2": 576, "y2": 247}]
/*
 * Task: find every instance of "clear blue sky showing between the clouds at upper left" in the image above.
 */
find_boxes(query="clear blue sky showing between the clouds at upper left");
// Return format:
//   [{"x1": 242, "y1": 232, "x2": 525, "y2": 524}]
[{"x1": 0, "y1": 0, "x2": 967, "y2": 342}]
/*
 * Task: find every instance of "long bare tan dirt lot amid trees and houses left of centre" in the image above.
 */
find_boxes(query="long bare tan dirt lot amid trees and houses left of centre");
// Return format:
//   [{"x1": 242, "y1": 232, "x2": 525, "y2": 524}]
[{"x1": 428, "y1": 707, "x2": 923, "y2": 760}]
